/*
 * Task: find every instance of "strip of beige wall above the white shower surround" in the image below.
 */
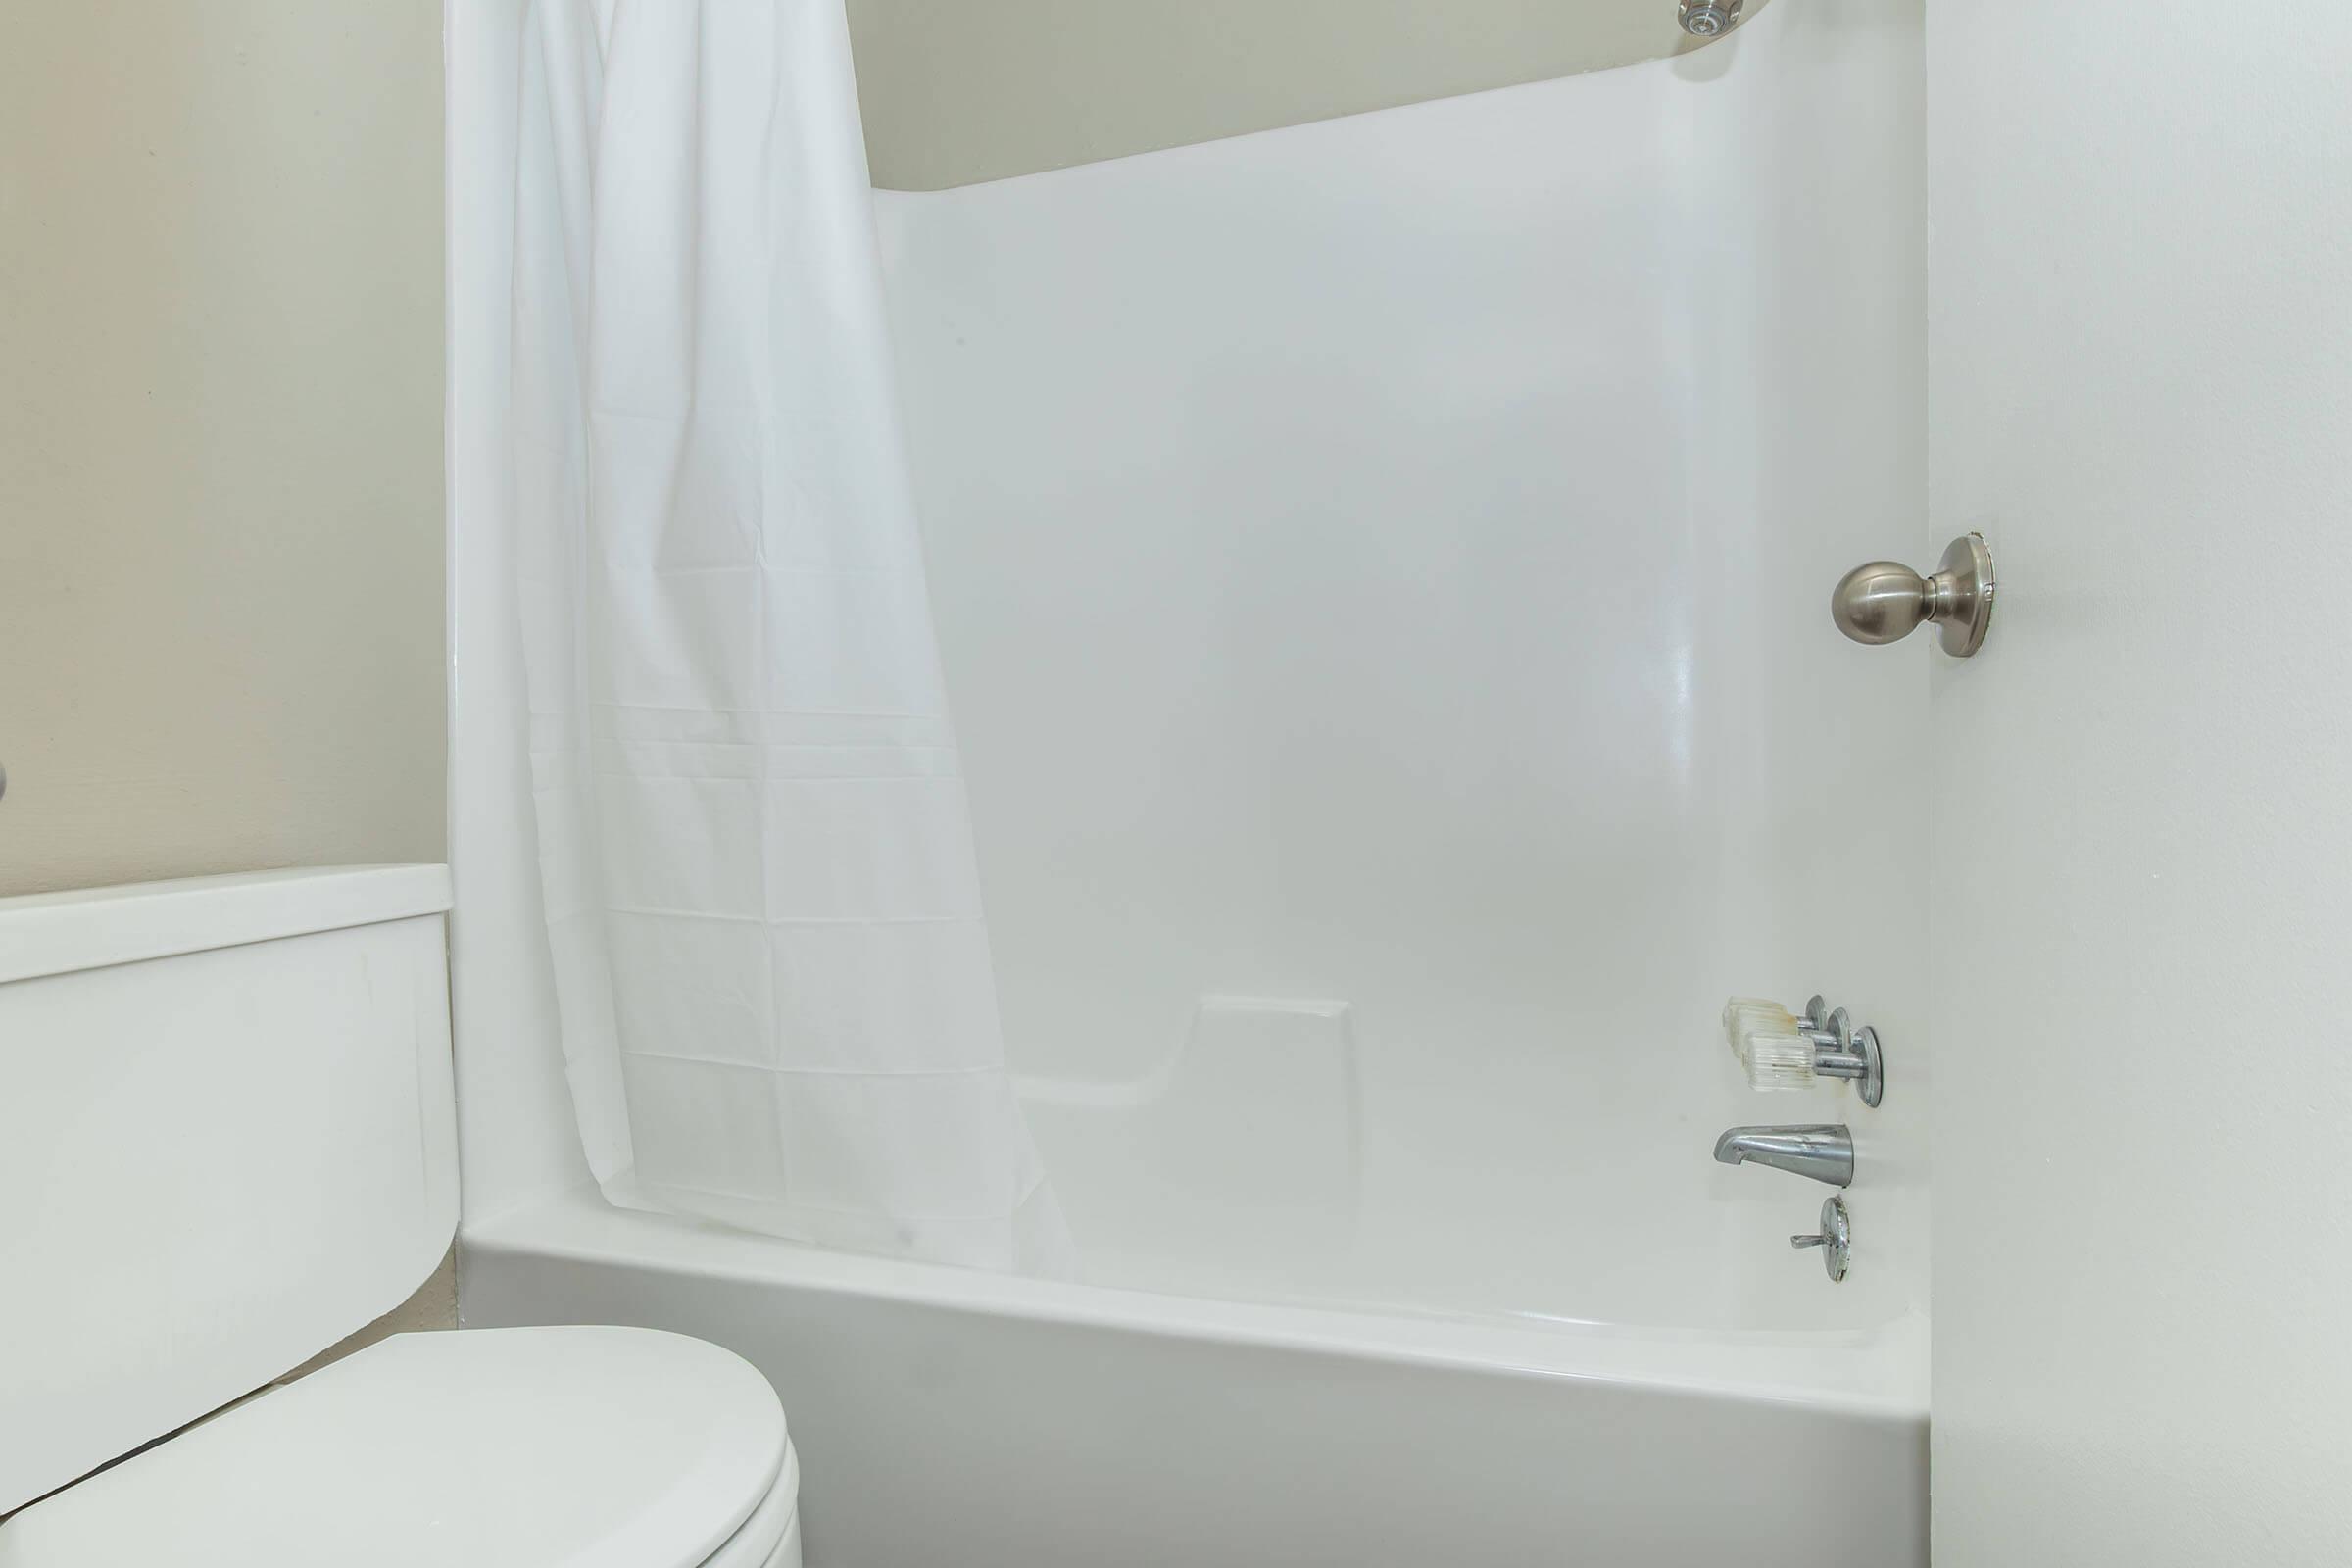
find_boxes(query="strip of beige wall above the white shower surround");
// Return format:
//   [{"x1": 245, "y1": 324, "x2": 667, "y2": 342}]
[{"x1": 849, "y1": 0, "x2": 1764, "y2": 190}]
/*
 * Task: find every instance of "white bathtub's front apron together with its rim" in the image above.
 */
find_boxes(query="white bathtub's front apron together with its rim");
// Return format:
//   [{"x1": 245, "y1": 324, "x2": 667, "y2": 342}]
[{"x1": 461, "y1": 1197, "x2": 1927, "y2": 1568}]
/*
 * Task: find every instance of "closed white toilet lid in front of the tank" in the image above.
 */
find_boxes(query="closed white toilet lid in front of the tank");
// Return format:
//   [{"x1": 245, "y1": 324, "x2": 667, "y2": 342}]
[{"x1": 0, "y1": 1328, "x2": 790, "y2": 1568}]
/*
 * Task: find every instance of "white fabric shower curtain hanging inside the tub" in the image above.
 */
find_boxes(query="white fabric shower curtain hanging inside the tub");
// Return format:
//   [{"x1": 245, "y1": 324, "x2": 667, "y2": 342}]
[{"x1": 510, "y1": 0, "x2": 1068, "y2": 1272}]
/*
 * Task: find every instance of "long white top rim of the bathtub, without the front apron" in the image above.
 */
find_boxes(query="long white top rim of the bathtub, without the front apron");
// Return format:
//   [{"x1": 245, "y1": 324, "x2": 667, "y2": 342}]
[{"x1": 459, "y1": 1187, "x2": 1929, "y2": 1425}]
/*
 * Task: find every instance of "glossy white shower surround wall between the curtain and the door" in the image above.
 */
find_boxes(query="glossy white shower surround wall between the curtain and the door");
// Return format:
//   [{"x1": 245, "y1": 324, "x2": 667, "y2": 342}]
[{"x1": 882, "y1": 0, "x2": 1927, "y2": 1326}]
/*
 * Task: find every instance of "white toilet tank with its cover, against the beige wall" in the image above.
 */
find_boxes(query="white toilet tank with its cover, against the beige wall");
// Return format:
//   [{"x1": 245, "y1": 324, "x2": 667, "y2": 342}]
[{"x1": 0, "y1": 865, "x2": 457, "y2": 1511}]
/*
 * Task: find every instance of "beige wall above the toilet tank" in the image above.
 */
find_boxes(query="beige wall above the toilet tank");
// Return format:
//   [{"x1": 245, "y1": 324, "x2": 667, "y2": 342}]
[{"x1": 0, "y1": 0, "x2": 445, "y2": 894}]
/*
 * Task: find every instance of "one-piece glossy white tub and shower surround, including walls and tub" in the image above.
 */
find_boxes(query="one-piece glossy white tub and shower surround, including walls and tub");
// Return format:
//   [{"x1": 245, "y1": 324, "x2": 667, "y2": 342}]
[{"x1": 449, "y1": 0, "x2": 1929, "y2": 1566}]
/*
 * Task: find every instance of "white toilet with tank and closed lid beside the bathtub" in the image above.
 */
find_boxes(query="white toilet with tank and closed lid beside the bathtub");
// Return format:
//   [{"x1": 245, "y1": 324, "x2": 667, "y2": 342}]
[{"x1": 0, "y1": 865, "x2": 800, "y2": 1568}]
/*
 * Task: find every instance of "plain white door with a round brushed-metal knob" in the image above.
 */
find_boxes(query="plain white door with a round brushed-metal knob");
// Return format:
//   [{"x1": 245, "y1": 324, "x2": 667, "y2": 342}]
[{"x1": 1929, "y1": 0, "x2": 2352, "y2": 1568}]
